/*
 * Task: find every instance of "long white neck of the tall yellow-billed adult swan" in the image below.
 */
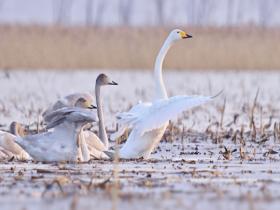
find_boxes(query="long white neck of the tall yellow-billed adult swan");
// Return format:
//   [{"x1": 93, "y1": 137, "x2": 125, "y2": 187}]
[{"x1": 154, "y1": 37, "x2": 172, "y2": 99}]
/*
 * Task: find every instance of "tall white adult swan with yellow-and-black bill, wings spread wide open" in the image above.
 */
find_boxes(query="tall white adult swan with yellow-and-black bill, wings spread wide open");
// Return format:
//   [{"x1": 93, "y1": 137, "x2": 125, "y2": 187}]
[{"x1": 110, "y1": 29, "x2": 219, "y2": 159}]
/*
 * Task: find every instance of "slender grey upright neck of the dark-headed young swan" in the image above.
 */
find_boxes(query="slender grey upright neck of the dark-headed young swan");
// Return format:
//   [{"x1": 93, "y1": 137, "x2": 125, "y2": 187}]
[{"x1": 95, "y1": 84, "x2": 109, "y2": 149}]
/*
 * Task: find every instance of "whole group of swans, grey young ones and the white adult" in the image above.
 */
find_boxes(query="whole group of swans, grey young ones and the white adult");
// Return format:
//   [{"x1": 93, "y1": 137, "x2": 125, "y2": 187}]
[{"x1": 0, "y1": 29, "x2": 219, "y2": 162}]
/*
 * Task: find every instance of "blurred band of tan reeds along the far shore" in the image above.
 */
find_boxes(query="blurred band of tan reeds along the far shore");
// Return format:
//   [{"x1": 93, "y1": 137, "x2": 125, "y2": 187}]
[{"x1": 0, "y1": 25, "x2": 280, "y2": 69}]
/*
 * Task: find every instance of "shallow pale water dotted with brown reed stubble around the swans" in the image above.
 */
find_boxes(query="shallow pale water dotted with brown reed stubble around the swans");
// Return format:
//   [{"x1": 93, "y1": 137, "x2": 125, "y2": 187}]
[{"x1": 0, "y1": 71, "x2": 280, "y2": 210}]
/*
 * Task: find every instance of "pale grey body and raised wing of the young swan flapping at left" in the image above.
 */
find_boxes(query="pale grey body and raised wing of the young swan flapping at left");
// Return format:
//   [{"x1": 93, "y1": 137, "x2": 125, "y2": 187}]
[{"x1": 7, "y1": 107, "x2": 97, "y2": 162}]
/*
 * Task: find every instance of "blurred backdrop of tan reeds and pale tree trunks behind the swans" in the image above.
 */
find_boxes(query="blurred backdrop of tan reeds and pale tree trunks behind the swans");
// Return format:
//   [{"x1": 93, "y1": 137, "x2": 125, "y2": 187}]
[{"x1": 0, "y1": 0, "x2": 280, "y2": 70}]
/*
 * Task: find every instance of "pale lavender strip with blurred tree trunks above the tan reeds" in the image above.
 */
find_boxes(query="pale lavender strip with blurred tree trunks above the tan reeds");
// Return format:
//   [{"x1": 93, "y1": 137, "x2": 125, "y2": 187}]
[{"x1": 0, "y1": 0, "x2": 280, "y2": 27}]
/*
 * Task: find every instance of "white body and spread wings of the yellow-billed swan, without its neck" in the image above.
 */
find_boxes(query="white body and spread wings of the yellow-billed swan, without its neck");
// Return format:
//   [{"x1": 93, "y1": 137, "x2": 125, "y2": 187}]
[{"x1": 117, "y1": 96, "x2": 212, "y2": 159}]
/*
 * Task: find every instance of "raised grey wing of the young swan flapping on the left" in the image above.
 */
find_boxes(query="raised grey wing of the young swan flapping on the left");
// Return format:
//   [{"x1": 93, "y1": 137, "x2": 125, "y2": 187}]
[{"x1": 45, "y1": 107, "x2": 97, "y2": 129}]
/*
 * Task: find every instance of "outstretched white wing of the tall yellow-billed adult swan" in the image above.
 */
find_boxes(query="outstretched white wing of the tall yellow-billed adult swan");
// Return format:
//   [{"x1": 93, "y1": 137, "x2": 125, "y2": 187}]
[{"x1": 133, "y1": 95, "x2": 212, "y2": 135}]
